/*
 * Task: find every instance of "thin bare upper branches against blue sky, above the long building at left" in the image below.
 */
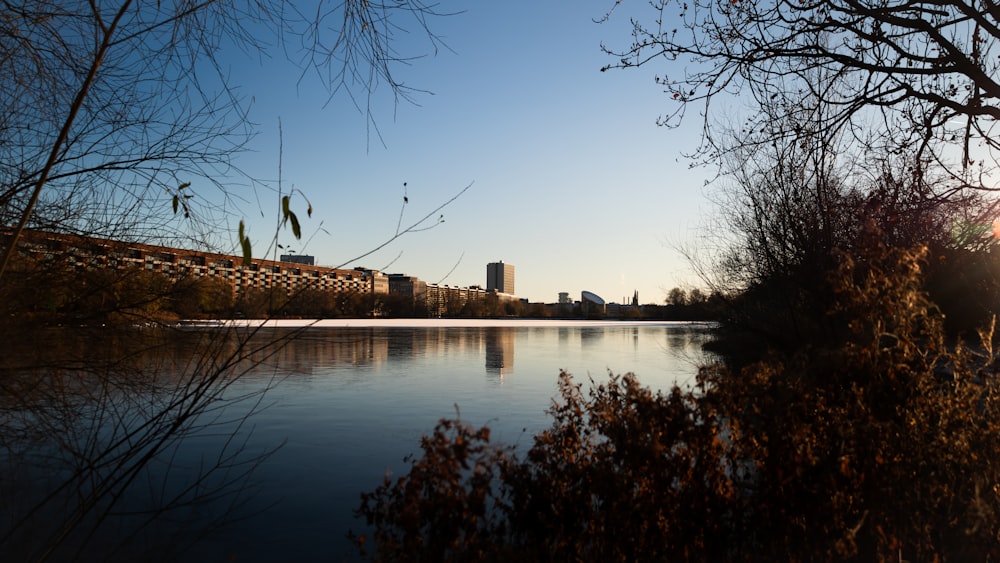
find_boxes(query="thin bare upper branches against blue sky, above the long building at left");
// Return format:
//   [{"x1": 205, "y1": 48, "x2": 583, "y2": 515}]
[{"x1": 0, "y1": 0, "x2": 452, "y2": 275}]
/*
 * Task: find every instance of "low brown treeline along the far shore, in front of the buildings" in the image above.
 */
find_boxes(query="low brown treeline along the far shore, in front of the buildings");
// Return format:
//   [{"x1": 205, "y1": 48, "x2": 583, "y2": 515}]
[{"x1": 0, "y1": 249, "x2": 736, "y2": 324}]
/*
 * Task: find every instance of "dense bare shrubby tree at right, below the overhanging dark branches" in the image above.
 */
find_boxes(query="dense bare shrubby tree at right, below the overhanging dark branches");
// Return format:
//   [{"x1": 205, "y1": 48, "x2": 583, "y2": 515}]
[{"x1": 701, "y1": 75, "x2": 997, "y2": 350}]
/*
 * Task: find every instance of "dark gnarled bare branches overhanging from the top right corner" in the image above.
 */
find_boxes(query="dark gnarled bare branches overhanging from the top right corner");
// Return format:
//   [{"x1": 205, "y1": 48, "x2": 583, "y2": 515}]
[{"x1": 606, "y1": 0, "x2": 1000, "y2": 183}]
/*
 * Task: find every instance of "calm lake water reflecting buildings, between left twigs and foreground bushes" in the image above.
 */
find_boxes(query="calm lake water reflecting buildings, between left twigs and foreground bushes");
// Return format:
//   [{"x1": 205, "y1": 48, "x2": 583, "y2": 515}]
[{"x1": 3, "y1": 322, "x2": 707, "y2": 562}]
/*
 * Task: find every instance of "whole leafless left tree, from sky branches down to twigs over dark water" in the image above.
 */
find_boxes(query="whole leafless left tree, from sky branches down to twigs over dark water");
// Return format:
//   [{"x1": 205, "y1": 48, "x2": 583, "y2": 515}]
[{"x1": 0, "y1": 0, "x2": 454, "y2": 561}]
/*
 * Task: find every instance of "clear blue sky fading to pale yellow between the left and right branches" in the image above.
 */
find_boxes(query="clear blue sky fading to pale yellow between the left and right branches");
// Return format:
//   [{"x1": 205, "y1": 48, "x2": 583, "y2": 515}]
[{"x1": 228, "y1": 0, "x2": 712, "y2": 303}]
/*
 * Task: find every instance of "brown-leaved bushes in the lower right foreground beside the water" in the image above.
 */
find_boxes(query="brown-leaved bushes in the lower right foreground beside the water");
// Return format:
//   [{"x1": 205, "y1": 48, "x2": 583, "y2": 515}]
[{"x1": 358, "y1": 244, "x2": 1000, "y2": 561}]
